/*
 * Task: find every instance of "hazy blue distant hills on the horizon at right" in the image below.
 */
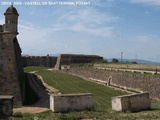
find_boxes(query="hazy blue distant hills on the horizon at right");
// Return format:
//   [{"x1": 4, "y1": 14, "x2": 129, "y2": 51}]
[{"x1": 106, "y1": 58, "x2": 160, "y2": 64}]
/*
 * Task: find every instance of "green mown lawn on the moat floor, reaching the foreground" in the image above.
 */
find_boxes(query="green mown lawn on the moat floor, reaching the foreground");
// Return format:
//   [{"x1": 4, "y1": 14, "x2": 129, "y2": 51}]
[{"x1": 15, "y1": 67, "x2": 160, "y2": 120}]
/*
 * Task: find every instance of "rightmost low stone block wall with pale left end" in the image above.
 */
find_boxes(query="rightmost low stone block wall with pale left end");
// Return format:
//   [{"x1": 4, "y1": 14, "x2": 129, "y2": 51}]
[{"x1": 112, "y1": 92, "x2": 151, "y2": 112}]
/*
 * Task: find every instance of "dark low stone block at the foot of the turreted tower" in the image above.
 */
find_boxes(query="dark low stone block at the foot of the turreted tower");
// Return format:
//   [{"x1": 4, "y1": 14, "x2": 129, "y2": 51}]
[{"x1": 0, "y1": 95, "x2": 13, "y2": 119}]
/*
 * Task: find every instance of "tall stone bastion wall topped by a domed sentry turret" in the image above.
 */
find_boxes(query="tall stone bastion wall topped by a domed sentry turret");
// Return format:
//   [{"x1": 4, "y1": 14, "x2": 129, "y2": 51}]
[{"x1": 0, "y1": 5, "x2": 25, "y2": 106}]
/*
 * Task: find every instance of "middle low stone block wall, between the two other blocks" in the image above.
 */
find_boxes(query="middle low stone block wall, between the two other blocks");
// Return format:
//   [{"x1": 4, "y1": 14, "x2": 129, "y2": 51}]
[{"x1": 50, "y1": 93, "x2": 94, "y2": 112}]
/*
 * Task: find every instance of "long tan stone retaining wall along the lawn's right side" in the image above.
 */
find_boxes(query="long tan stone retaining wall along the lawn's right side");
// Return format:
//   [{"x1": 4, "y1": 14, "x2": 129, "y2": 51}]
[{"x1": 69, "y1": 67, "x2": 160, "y2": 99}]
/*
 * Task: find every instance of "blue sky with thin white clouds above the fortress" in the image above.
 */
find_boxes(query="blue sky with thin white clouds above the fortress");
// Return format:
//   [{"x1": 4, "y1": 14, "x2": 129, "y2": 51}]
[{"x1": 0, "y1": 0, "x2": 160, "y2": 62}]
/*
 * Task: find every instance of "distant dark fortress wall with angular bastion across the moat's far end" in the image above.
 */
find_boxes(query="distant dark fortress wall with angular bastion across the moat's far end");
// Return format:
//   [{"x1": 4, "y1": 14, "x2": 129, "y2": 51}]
[{"x1": 22, "y1": 54, "x2": 103, "y2": 69}]
